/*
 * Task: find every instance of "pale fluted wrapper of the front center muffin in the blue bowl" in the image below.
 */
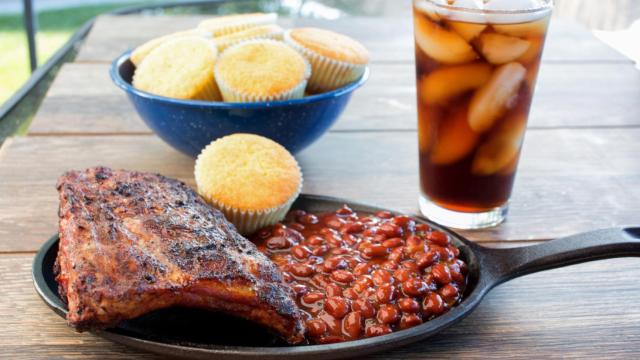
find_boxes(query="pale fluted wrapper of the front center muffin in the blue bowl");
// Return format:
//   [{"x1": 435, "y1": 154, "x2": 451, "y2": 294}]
[{"x1": 214, "y1": 39, "x2": 311, "y2": 103}]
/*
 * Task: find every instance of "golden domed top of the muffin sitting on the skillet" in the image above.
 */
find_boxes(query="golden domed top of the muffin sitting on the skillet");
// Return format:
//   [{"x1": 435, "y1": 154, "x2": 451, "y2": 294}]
[{"x1": 195, "y1": 134, "x2": 302, "y2": 211}]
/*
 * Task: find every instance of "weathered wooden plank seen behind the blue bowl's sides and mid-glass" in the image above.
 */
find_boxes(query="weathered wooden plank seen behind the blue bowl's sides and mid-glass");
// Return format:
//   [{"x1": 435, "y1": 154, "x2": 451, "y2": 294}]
[{"x1": 29, "y1": 63, "x2": 640, "y2": 135}]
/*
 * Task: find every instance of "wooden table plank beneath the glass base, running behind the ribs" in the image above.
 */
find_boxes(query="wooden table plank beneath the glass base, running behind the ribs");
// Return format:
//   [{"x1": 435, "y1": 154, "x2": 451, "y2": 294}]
[{"x1": 0, "y1": 129, "x2": 640, "y2": 251}]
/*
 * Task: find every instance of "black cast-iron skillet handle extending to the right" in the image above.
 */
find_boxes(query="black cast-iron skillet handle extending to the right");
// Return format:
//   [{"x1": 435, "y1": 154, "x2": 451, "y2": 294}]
[{"x1": 481, "y1": 227, "x2": 640, "y2": 285}]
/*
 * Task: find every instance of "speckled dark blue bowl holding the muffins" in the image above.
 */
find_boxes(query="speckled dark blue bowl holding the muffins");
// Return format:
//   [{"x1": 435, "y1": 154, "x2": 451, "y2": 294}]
[{"x1": 110, "y1": 51, "x2": 369, "y2": 158}]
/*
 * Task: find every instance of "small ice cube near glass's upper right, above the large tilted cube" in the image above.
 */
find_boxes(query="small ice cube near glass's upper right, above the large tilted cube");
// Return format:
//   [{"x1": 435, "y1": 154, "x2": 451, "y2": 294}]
[{"x1": 478, "y1": 33, "x2": 530, "y2": 65}]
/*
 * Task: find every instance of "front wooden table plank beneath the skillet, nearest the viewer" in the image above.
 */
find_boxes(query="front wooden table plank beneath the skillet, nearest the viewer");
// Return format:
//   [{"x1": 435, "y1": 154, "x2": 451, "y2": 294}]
[{"x1": 0, "y1": 255, "x2": 640, "y2": 359}]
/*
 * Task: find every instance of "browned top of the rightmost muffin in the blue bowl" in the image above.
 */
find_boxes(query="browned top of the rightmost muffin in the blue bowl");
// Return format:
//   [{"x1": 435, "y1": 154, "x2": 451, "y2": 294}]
[{"x1": 289, "y1": 27, "x2": 369, "y2": 64}]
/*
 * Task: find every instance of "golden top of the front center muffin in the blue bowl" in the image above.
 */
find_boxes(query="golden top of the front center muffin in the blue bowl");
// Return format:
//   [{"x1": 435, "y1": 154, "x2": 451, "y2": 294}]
[{"x1": 215, "y1": 40, "x2": 310, "y2": 96}]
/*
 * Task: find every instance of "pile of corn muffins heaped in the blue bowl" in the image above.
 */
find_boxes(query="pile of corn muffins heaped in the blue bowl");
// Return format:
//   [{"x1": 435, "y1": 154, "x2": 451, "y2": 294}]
[{"x1": 130, "y1": 13, "x2": 369, "y2": 102}]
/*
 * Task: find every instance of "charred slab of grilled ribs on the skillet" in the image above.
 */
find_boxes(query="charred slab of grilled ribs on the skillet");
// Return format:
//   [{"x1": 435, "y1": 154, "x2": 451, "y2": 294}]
[{"x1": 56, "y1": 167, "x2": 304, "y2": 343}]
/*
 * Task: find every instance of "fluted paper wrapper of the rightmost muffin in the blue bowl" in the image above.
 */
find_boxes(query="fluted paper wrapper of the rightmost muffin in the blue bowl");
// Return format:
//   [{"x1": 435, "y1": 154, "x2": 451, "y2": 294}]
[{"x1": 284, "y1": 30, "x2": 367, "y2": 93}]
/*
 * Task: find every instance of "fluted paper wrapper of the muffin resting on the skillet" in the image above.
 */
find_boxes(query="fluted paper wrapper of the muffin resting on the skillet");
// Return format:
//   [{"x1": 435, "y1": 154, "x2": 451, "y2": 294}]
[{"x1": 198, "y1": 172, "x2": 303, "y2": 235}]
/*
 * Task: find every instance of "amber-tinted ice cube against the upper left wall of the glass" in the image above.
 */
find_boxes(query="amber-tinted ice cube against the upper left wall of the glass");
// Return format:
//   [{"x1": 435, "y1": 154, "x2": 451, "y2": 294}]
[{"x1": 414, "y1": 14, "x2": 477, "y2": 64}]
